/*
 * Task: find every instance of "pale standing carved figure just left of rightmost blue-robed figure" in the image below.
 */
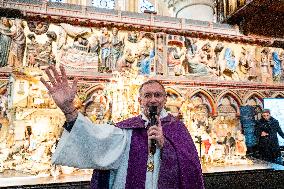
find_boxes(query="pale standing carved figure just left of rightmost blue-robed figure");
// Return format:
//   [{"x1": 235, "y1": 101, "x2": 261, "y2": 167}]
[{"x1": 260, "y1": 48, "x2": 272, "y2": 82}]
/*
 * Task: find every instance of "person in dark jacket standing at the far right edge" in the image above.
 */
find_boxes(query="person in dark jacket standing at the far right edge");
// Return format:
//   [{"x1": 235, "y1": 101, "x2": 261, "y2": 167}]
[{"x1": 257, "y1": 109, "x2": 284, "y2": 163}]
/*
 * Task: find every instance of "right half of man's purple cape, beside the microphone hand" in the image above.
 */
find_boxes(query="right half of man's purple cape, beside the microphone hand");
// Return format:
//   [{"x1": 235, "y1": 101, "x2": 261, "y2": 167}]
[{"x1": 158, "y1": 120, "x2": 204, "y2": 189}]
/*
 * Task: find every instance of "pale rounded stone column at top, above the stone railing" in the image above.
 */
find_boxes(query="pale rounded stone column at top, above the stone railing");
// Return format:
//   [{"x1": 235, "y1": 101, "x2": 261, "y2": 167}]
[{"x1": 166, "y1": 0, "x2": 214, "y2": 22}]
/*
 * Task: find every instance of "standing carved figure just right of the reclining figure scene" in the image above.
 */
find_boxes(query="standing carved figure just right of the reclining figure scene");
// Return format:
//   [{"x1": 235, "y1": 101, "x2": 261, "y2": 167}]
[{"x1": 99, "y1": 27, "x2": 110, "y2": 71}]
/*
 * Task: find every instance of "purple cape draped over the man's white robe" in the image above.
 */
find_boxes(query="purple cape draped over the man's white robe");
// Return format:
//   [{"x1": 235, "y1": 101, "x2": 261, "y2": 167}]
[{"x1": 91, "y1": 114, "x2": 204, "y2": 189}]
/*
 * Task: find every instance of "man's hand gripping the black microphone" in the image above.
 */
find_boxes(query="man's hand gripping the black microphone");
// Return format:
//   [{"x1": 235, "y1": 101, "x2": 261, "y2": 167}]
[{"x1": 147, "y1": 116, "x2": 165, "y2": 149}]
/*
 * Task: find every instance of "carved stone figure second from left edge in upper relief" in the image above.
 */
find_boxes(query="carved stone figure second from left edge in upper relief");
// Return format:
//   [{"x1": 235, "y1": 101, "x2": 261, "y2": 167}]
[{"x1": 6, "y1": 19, "x2": 26, "y2": 67}]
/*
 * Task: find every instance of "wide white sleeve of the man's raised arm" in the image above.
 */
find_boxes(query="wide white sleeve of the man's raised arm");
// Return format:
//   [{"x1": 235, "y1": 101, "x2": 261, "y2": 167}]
[{"x1": 52, "y1": 113, "x2": 128, "y2": 169}]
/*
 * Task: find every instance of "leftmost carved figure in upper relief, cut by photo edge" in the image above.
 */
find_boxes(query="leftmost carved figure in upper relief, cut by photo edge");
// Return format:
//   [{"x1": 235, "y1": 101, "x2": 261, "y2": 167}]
[{"x1": 0, "y1": 17, "x2": 11, "y2": 67}]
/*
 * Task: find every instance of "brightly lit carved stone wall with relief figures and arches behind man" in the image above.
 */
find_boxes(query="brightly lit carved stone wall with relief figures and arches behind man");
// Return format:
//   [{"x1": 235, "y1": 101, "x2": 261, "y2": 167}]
[{"x1": 0, "y1": 1, "x2": 284, "y2": 179}]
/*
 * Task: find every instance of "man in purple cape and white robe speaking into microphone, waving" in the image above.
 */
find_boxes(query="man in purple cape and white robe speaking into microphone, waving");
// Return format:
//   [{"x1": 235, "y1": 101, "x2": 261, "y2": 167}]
[{"x1": 41, "y1": 66, "x2": 204, "y2": 189}]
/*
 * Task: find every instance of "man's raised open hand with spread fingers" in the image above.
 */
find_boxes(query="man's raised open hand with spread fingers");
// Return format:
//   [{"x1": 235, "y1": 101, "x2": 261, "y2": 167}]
[{"x1": 40, "y1": 65, "x2": 78, "y2": 121}]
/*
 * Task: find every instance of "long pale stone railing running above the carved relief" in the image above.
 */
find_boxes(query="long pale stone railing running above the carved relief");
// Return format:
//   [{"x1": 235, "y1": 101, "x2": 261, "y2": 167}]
[{"x1": 0, "y1": 0, "x2": 276, "y2": 43}]
